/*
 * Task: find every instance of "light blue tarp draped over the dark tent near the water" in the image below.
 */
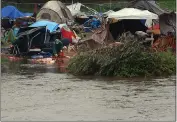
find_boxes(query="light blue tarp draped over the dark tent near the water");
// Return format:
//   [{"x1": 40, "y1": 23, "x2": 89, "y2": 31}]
[{"x1": 29, "y1": 20, "x2": 59, "y2": 32}]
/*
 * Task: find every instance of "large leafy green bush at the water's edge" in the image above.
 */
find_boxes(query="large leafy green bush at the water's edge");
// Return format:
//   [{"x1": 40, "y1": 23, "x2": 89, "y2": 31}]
[{"x1": 68, "y1": 33, "x2": 176, "y2": 77}]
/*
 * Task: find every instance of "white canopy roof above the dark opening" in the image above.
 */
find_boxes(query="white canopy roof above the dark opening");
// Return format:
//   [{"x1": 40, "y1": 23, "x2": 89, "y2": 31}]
[{"x1": 108, "y1": 8, "x2": 158, "y2": 19}]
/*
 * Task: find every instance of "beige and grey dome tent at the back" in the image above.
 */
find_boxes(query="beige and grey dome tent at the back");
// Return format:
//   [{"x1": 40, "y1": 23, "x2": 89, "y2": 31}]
[{"x1": 36, "y1": 1, "x2": 73, "y2": 23}]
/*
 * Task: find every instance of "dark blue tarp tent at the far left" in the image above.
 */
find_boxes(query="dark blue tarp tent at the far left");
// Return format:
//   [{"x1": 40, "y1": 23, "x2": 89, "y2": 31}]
[{"x1": 1, "y1": 6, "x2": 33, "y2": 19}]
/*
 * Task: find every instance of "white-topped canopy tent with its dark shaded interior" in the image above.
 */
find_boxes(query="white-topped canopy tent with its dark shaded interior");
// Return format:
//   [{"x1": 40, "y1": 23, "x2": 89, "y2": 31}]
[{"x1": 108, "y1": 8, "x2": 158, "y2": 40}]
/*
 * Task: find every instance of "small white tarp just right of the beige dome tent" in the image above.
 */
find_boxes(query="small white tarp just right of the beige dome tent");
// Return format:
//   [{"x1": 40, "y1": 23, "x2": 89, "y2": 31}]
[{"x1": 67, "y1": 3, "x2": 82, "y2": 16}]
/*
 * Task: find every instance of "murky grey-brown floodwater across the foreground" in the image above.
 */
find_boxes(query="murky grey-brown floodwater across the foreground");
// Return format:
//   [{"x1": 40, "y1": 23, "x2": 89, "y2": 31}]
[{"x1": 1, "y1": 63, "x2": 176, "y2": 121}]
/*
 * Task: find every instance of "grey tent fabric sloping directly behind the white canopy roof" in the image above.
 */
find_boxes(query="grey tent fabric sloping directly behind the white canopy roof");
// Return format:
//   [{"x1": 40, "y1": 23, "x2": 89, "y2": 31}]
[{"x1": 128, "y1": 0, "x2": 165, "y2": 15}]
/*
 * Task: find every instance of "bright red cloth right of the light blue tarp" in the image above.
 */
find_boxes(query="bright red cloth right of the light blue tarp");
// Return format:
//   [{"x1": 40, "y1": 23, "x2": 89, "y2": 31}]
[{"x1": 61, "y1": 28, "x2": 76, "y2": 43}]
